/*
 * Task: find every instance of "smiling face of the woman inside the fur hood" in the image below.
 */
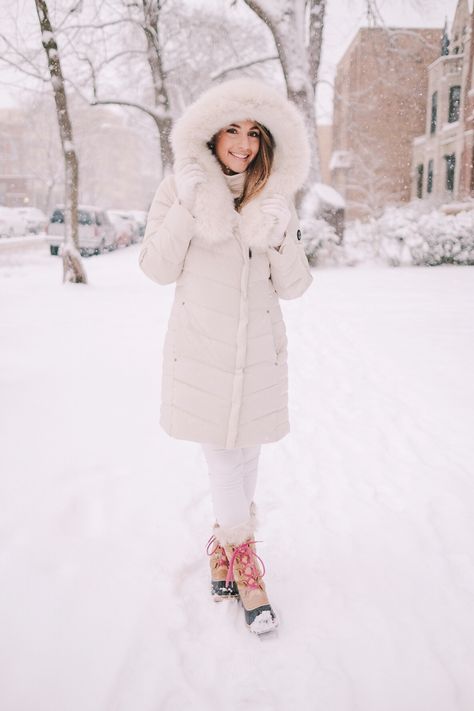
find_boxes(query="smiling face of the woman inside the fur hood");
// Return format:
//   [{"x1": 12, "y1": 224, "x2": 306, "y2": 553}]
[{"x1": 215, "y1": 121, "x2": 260, "y2": 173}]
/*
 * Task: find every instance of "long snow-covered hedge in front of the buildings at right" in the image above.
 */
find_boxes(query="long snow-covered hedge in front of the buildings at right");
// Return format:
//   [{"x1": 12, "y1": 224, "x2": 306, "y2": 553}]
[{"x1": 302, "y1": 202, "x2": 474, "y2": 266}]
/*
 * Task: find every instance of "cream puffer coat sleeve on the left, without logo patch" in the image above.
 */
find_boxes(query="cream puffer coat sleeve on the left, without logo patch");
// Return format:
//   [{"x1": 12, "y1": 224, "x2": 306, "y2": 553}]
[{"x1": 138, "y1": 176, "x2": 194, "y2": 284}]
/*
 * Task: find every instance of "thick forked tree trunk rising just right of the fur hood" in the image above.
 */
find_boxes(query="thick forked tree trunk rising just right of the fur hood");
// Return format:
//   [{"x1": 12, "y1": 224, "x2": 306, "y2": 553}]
[{"x1": 244, "y1": 0, "x2": 326, "y2": 184}]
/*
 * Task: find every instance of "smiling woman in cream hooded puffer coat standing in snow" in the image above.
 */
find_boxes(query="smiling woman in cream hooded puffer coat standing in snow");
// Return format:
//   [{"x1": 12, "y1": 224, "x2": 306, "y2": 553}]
[{"x1": 140, "y1": 79, "x2": 312, "y2": 634}]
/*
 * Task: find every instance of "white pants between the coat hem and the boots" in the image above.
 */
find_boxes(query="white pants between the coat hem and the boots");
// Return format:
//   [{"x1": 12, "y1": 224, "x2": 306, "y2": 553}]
[{"x1": 202, "y1": 444, "x2": 260, "y2": 526}]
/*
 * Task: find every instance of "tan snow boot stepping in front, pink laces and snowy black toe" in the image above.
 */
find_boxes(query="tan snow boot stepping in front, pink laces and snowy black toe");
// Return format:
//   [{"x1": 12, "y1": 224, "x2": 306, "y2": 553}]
[{"x1": 215, "y1": 506, "x2": 278, "y2": 634}]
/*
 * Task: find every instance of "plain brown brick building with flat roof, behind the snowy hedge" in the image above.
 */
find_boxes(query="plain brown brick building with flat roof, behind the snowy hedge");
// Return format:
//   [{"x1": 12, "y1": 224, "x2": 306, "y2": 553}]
[{"x1": 330, "y1": 28, "x2": 442, "y2": 219}]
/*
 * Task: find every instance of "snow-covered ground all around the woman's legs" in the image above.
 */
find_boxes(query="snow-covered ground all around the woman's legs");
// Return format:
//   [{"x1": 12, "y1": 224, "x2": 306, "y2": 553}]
[{"x1": 0, "y1": 246, "x2": 474, "y2": 711}]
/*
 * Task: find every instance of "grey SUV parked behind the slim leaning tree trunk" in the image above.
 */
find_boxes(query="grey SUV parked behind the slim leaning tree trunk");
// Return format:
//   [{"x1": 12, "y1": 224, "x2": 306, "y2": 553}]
[{"x1": 47, "y1": 205, "x2": 115, "y2": 256}]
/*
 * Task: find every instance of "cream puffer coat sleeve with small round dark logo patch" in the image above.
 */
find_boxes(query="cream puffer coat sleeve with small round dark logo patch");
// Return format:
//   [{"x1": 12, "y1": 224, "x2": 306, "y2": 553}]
[{"x1": 268, "y1": 200, "x2": 313, "y2": 299}]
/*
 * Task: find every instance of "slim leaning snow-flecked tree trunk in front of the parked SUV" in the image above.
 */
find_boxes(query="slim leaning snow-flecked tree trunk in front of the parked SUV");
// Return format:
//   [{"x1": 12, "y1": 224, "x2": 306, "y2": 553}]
[{"x1": 35, "y1": 0, "x2": 87, "y2": 284}]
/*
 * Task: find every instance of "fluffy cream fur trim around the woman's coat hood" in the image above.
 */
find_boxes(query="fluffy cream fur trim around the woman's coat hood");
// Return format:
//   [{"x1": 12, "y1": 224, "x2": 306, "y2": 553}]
[{"x1": 171, "y1": 78, "x2": 310, "y2": 250}]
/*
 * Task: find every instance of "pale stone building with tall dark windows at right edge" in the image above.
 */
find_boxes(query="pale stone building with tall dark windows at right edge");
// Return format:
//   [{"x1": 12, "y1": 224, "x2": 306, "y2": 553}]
[{"x1": 411, "y1": 0, "x2": 474, "y2": 205}]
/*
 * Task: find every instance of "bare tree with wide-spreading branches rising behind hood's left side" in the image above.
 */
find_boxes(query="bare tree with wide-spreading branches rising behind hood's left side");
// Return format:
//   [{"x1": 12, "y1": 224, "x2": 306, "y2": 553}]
[{"x1": 70, "y1": 0, "x2": 278, "y2": 172}]
